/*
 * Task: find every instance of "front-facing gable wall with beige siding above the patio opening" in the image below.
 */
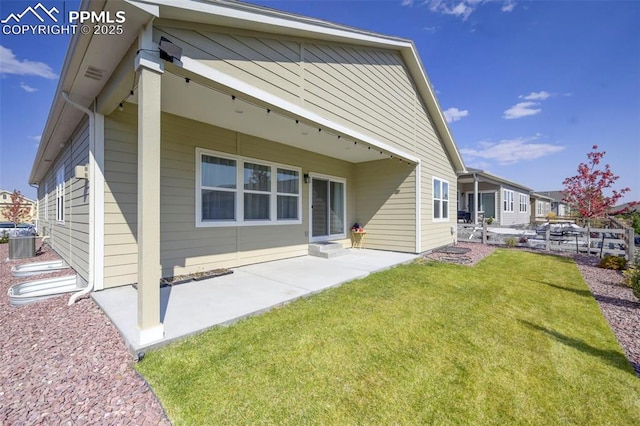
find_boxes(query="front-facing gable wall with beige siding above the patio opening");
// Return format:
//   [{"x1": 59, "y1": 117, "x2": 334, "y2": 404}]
[{"x1": 154, "y1": 22, "x2": 457, "y2": 251}]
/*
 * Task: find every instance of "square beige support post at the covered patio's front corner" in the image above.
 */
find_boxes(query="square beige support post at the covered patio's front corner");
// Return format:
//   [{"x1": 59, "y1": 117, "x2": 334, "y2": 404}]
[{"x1": 135, "y1": 23, "x2": 164, "y2": 345}]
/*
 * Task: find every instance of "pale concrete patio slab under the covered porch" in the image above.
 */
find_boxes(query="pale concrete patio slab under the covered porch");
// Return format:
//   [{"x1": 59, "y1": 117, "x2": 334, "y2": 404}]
[{"x1": 92, "y1": 249, "x2": 418, "y2": 354}]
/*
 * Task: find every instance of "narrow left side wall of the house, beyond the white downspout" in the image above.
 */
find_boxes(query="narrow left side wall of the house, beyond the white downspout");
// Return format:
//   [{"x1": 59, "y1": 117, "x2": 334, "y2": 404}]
[{"x1": 38, "y1": 119, "x2": 89, "y2": 281}]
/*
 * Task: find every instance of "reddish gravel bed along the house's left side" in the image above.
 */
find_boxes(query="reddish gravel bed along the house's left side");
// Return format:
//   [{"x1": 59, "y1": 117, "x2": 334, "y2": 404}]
[{"x1": 0, "y1": 244, "x2": 171, "y2": 425}]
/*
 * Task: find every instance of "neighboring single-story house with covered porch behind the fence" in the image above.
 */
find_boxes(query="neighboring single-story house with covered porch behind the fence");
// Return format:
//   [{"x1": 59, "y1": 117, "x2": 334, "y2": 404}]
[{"x1": 458, "y1": 167, "x2": 533, "y2": 225}]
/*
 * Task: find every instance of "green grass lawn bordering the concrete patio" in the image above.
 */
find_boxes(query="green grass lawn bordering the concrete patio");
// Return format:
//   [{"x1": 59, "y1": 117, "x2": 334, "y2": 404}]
[{"x1": 137, "y1": 250, "x2": 640, "y2": 425}]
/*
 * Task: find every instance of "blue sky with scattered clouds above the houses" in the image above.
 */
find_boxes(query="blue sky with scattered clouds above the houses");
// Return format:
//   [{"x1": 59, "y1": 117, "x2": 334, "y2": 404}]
[{"x1": 0, "y1": 0, "x2": 640, "y2": 205}]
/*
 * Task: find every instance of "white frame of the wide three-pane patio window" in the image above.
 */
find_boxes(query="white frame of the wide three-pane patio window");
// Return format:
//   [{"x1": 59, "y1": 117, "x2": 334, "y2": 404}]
[{"x1": 195, "y1": 148, "x2": 302, "y2": 228}]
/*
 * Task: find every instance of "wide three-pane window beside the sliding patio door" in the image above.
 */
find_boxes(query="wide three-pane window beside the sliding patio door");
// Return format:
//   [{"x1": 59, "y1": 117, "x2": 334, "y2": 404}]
[{"x1": 196, "y1": 148, "x2": 302, "y2": 226}]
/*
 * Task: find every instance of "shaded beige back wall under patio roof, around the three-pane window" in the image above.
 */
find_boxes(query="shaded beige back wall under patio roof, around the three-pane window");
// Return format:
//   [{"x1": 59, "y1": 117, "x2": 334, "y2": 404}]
[{"x1": 104, "y1": 104, "x2": 356, "y2": 288}]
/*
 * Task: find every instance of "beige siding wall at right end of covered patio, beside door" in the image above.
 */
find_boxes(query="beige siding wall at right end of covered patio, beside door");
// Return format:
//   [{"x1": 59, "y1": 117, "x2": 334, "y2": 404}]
[{"x1": 355, "y1": 160, "x2": 416, "y2": 253}]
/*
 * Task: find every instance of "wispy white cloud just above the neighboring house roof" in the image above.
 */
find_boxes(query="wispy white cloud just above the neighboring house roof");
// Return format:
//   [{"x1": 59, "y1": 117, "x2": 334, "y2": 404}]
[{"x1": 460, "y1": 135, "x2": 564, "y2": 165}]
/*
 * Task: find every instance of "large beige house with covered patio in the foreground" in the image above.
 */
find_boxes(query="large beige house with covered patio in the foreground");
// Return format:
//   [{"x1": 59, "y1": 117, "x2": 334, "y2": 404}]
[{"x1": 30, "y1": 0, "x2": 464, "y2": 344}]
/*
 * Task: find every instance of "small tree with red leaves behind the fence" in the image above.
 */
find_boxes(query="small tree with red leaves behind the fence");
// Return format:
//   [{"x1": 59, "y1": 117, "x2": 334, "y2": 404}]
[{"x1": 562, "y1": 145, "x2": 631, "y2": 246}]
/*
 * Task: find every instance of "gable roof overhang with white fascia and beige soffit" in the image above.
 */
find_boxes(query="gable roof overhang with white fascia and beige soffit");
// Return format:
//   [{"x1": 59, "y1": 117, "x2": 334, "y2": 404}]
[{"x1": 29, "y1": 0, "x2": 465, "y2": 183}]
